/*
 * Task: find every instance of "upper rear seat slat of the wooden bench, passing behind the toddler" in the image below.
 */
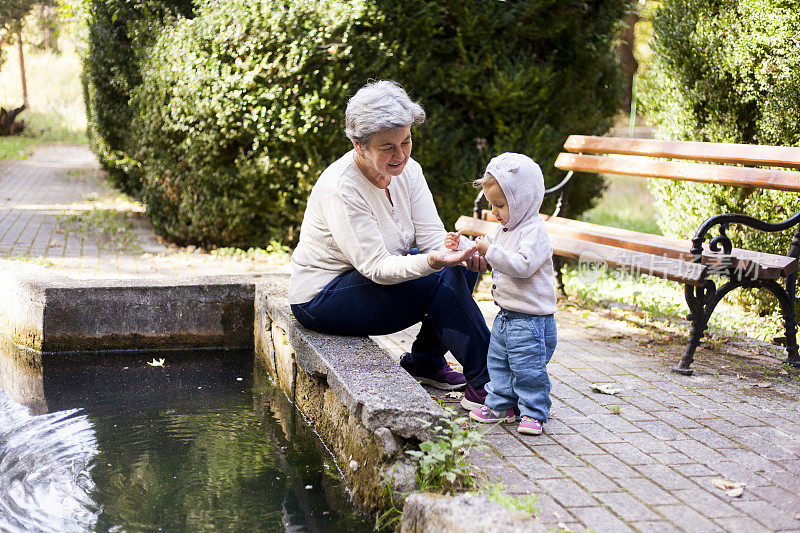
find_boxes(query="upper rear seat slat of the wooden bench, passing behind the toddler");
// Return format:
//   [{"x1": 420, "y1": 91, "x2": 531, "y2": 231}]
[{"x1": 456, "y1": 216, "x2": 798, "y2": 279}]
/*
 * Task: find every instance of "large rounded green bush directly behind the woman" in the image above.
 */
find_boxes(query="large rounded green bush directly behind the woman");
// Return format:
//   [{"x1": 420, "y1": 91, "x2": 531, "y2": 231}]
[{"x1": 97, "y1": 0, "x2": 627, "y2": 247}]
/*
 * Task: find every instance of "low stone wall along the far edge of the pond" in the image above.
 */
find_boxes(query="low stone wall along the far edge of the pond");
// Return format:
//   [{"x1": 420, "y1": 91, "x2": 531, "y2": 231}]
[{"x1": 0, "y1": 264, "x2": 255, "y2": 353}]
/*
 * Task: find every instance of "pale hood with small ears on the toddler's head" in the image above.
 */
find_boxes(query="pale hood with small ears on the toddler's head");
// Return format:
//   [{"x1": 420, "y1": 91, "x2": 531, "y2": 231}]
[{"x1": 484, "y1": 152, "x2": 544, "y2": 230}]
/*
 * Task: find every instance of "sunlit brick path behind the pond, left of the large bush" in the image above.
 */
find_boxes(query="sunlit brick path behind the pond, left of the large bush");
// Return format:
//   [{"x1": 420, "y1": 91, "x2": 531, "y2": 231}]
[{"x1": 0, "y1": 145, "x2": 286, "y2": 278}]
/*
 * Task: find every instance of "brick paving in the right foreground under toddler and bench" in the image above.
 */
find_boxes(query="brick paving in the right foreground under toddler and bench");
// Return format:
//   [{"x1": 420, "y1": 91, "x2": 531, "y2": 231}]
[{"x1": 376, "y1": 302, "x2": 800, "y2": 533}]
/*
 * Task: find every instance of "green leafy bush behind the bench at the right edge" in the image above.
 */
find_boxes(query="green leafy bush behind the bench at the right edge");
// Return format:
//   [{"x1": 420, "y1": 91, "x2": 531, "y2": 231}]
[{"x1": 640, "y1": 0, "x2": 800, "y2": 311}]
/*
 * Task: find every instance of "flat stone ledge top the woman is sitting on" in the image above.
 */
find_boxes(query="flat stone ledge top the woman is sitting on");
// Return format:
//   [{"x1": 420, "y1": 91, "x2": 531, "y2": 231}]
[{"x1": 255, "y1": 275, "x2": 444, "y2": 440}]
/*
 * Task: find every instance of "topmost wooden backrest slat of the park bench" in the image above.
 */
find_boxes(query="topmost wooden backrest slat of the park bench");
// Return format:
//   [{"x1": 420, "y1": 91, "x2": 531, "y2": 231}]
[{"x1": 564, "y1": 135, "x2": 800, "y2": 168}]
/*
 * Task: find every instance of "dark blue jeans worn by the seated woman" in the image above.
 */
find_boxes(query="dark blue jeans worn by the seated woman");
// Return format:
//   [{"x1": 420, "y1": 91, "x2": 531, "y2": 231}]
[{"x1": 292, "y1": 266, "x2": 489, "y2": 387}]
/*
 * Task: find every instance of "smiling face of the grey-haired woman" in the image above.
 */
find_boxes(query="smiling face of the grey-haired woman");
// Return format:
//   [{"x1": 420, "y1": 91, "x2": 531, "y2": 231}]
[{"x1": 353, "y1": 126, "x2": 411, "y2": 189}]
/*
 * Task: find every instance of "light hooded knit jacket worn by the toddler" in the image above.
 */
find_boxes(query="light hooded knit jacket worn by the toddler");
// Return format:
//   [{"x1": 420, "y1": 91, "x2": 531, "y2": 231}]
[{"x1": 486, "y1": 152, "x2": 556, "y2": 315}]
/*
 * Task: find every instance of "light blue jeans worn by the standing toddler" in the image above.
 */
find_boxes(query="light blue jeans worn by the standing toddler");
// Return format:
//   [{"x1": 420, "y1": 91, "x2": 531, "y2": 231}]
[{"x1": 486, "y1": 309, "x2": 556, "y2": 424}]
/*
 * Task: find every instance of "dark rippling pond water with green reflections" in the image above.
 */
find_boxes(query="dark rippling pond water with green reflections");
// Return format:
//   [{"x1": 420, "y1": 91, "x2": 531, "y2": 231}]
[{"x1": 0, "y1": 351, "x2": 372, "y2": 532}]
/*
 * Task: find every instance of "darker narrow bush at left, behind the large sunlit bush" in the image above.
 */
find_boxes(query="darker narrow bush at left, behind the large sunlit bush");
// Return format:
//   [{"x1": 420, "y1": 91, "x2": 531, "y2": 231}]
[{"x1": 83, "y1": 0, "x2": 192, "y2": 196}]
